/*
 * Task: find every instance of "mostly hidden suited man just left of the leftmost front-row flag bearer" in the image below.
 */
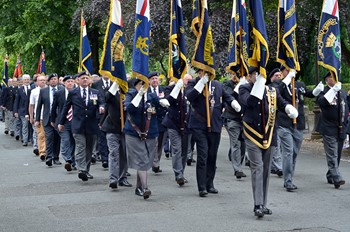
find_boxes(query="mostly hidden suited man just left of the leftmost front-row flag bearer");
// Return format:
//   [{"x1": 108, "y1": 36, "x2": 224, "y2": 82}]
[{"x1": 91, "y1": 75, "x2": 111, "y2": 168}]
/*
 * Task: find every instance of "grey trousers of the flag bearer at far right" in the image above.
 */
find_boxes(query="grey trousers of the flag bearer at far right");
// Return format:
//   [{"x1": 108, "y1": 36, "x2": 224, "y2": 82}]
[{"x1": 323, "y1": 135, "x2": 344, "y2": 182}]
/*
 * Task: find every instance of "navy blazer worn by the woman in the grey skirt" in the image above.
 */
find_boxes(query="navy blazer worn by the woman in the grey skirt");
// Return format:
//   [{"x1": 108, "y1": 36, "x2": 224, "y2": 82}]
[{"x1": 124, "y1": 89, "x2": 159, "y2": 139}]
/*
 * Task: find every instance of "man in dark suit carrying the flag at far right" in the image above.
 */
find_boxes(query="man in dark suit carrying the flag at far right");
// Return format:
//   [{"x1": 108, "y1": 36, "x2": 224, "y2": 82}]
[{"x1": 316, "y1": 72, "x2": 349, "y2": 189}]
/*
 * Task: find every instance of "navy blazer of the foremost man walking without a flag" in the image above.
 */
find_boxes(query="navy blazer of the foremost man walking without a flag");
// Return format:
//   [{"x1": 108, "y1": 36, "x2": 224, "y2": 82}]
[{"x1": 59, "y1": 87, "x2": 104, "y2": 134}]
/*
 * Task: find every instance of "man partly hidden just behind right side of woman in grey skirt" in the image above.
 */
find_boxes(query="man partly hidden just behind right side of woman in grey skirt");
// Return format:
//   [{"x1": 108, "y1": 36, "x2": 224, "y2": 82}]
[{"x1": 147, "y1": 72, "x2": 167, "y2": 173}]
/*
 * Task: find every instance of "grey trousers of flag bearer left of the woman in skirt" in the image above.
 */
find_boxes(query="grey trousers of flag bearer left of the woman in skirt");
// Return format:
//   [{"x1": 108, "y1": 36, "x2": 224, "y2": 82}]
[{"x1": 106, "y1": 133, "x2": 128, "y2": 183}]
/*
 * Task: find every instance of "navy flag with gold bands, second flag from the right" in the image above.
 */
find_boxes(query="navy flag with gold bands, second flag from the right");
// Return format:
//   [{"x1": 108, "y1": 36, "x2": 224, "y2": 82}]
[{"x1": 277, "y1": 0, "x2": 300, "y2": 71}]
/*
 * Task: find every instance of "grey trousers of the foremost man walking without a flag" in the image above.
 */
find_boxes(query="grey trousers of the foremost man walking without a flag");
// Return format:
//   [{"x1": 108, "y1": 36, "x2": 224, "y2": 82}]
[{"x1": 73, "y1": 134, "x2": 97, "y2": 172}]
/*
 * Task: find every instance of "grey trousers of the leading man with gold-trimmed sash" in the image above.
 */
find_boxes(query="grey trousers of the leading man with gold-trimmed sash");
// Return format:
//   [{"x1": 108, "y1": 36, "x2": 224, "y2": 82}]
[{"x1": 245, "y1": 139, "x2": 274, "y2": 206}]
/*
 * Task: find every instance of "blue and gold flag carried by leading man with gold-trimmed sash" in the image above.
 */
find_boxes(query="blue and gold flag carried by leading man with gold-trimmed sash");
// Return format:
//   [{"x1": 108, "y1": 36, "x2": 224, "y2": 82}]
[{"x1": 248, "y1": 0, "x2": 269, "y2": 78}]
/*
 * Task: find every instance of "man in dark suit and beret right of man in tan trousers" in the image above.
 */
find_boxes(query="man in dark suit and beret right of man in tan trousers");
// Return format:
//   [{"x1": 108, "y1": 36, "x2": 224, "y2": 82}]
[{"x1": 35, "y1": 73, "x2": 62, "y2": 167}]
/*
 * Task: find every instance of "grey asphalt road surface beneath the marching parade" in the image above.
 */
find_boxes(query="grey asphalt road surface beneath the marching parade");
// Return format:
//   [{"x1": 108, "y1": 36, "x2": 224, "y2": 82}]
[{"x1": 0, "y1": 123, "x2": 350, "y2": 232}]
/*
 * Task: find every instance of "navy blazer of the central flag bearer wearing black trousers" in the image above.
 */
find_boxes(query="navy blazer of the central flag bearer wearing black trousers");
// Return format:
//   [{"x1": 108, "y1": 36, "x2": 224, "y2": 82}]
[{"x1": 186, "y1": 77, "x2": 235, "y2": 133}]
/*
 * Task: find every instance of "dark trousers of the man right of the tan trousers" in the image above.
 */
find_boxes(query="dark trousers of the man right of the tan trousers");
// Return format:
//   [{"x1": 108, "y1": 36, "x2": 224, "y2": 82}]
[{"x1": 44, "y1": 126, "x2": 61, "y2": 160}]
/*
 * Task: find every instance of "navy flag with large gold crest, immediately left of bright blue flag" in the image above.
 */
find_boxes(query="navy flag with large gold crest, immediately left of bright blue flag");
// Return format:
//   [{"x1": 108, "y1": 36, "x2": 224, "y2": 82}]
[{"x1": 100, "y1": 0, "x2": 128, "y2": 93}]
